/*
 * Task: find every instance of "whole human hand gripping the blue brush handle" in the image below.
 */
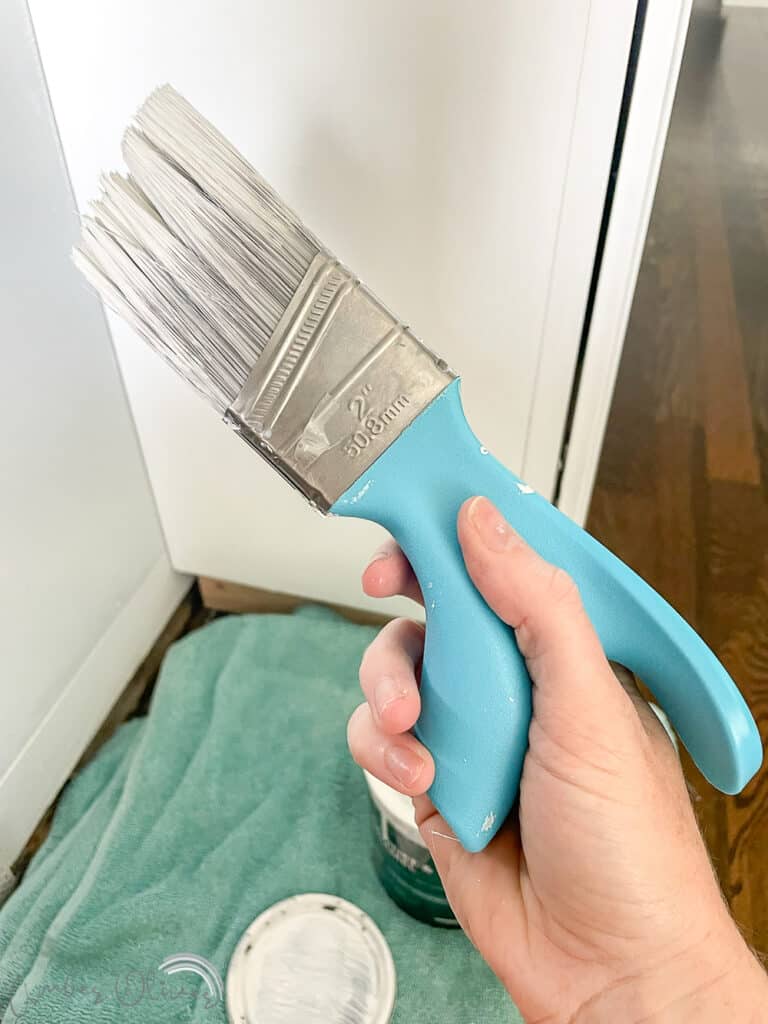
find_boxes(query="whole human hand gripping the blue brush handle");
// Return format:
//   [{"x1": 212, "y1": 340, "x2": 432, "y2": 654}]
[{"x1": 348, "y1": 498, "x2": 768, "y2": 1024}]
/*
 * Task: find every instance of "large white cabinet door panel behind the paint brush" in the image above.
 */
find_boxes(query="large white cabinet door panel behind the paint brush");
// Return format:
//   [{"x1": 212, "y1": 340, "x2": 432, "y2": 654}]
[{"x1": 31, "y1": 0, "x2": 636, "y2": 604}]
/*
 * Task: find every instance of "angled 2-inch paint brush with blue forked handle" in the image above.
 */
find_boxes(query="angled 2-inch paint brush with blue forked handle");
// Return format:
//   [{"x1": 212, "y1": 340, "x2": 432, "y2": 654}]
[{"x1": 75, "y1": 86, "x2": 762, "y2": 851}]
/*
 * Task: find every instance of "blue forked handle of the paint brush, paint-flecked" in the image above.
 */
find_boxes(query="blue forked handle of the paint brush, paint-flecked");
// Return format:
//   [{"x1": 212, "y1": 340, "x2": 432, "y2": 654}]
[{"x1": 332, "y1": 381, "x2": 762, "y2": 851}]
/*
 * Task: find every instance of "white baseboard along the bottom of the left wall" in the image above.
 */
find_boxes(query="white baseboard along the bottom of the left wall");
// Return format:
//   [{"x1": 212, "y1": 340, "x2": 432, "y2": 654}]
[{"x1": 0, "y1": 555, "x2": 189, "y2": 867}]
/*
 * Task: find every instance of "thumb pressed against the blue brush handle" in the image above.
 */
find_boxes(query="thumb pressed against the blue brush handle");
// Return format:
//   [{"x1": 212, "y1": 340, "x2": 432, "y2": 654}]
[{"x1": 458, "y1": 498, "x2": 637, "y2": 749}]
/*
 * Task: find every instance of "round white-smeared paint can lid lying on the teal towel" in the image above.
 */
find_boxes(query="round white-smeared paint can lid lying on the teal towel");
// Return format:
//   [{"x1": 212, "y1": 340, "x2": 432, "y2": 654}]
[{"x1": 226, "y1": 893, "x2": 395, "y2": 1024}]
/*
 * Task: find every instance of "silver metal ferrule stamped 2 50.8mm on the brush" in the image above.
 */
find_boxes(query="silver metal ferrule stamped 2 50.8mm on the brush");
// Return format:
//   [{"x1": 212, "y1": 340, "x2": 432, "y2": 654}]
[{"x1": 224, "y1": 251, "x2": 456, "y2": 512}]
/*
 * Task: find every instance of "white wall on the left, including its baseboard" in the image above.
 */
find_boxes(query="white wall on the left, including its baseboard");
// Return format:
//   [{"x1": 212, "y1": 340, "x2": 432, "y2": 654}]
[{"x1": 0, "y1": 0, "x2": 184, "y2": 864}]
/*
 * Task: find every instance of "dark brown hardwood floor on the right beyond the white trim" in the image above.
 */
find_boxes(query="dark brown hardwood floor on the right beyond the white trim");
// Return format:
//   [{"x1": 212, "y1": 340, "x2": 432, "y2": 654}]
[{"x1": 589, "y1": 0, "x2": 768, "y2": 953}]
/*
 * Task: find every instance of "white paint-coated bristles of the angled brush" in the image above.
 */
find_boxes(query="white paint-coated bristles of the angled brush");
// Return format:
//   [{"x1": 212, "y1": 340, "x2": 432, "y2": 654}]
[{"x1": 75, "y1": 85, "x2": 321, "y2": 412}]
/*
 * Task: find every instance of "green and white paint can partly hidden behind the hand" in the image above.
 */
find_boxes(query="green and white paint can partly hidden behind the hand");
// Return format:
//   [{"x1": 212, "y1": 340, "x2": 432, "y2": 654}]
[{"x1": 364, "y1": 772, "x2": 459, "y2": 928}]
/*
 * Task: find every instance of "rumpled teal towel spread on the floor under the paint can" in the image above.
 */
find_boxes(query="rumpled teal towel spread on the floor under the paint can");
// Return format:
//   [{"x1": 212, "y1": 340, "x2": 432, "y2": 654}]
[{"x1": 0, "y1": 608, "x2": 520, "y2": 1024}]
